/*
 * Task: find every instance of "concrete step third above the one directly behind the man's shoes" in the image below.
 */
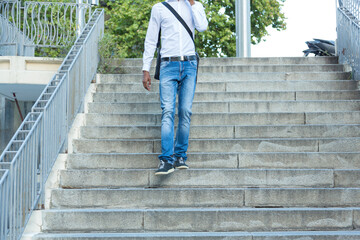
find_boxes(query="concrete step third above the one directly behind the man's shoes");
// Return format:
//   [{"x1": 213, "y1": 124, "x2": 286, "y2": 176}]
[{"x1": 85, "y1": 111, "x2": 360, "y2": 126}]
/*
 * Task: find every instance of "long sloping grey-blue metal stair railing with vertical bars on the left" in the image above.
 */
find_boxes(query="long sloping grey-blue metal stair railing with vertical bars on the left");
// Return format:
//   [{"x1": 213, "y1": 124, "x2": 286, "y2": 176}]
[{"x1": 0, "y1": 9, "x2": 104, "y2": 240}]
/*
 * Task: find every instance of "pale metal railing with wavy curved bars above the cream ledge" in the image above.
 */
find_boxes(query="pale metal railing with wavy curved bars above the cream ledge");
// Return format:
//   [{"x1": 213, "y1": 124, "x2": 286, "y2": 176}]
[{"x1": 0, "y1": 0, "x2": 91, "y2": 56}]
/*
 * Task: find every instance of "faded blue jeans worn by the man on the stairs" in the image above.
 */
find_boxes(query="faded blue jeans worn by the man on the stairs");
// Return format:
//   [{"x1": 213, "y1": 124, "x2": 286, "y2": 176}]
[{"x1": 159, "y1": 60, "x2": 197, "y2": 164}]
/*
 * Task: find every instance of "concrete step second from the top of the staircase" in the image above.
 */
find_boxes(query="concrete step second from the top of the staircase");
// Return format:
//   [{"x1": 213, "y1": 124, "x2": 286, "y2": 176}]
[{"x1": 120, "y1": 64, "x2": 346, "y2": 75}]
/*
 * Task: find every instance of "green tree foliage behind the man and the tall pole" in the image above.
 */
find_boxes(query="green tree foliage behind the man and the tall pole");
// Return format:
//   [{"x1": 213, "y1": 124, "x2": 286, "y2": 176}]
[{"x1": 106, "y1": 0, "x2": 286, "y2": 57}]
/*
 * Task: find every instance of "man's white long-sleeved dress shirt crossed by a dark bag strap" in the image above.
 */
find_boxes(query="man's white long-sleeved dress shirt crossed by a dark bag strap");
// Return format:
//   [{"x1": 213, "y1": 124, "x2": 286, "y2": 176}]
[{"x1": 143, "y1": 0, "x2": 208, "y2": 71}]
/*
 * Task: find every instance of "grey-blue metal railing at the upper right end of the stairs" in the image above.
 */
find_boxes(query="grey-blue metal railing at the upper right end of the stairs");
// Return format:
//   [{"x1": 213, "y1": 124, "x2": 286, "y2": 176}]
[{"x1": 336, "y1": 0, "x2": 360, "y2": 80}]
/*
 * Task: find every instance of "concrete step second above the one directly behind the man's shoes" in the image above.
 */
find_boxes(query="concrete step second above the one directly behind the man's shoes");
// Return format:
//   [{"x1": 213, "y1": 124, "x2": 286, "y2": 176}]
[{"x1": 80, "y1": 125, "x2": 360, "y2": 139}]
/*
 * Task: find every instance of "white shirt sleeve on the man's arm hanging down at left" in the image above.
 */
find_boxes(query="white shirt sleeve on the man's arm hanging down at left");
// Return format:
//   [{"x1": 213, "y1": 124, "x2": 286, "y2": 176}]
[{"x1": 142, "y1": 5, "x2": 160, "y2": 71}]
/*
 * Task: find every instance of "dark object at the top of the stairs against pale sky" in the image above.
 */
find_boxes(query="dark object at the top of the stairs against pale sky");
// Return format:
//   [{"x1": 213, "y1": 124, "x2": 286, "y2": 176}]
[{"x1": 303, "y1": 38, "x2": 335, "y2": 57}]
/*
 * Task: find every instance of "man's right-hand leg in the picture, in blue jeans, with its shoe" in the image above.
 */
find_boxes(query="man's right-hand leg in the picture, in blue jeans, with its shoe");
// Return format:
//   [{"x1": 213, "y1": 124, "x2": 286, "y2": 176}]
[{"x1": 174, "y1": 60, "x2": 197, "y2": 169}]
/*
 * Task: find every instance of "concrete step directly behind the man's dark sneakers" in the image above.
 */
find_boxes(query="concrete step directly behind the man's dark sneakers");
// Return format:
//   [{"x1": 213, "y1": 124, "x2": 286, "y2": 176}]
[{"x1": 67, "y1": 152, "x2": 360, "y2": 170}]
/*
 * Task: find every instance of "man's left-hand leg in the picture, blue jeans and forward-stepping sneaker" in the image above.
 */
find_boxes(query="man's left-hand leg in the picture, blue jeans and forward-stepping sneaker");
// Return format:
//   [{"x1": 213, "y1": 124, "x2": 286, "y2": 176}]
[{"x1": 155, "y1": 62, "x2": 179, "y2": 175}]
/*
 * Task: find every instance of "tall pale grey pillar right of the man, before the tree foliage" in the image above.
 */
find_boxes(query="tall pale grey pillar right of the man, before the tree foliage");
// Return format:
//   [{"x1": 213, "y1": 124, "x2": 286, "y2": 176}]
[{"x1": 235, "y1": 0, "x2": 251, "y2": 57}]
